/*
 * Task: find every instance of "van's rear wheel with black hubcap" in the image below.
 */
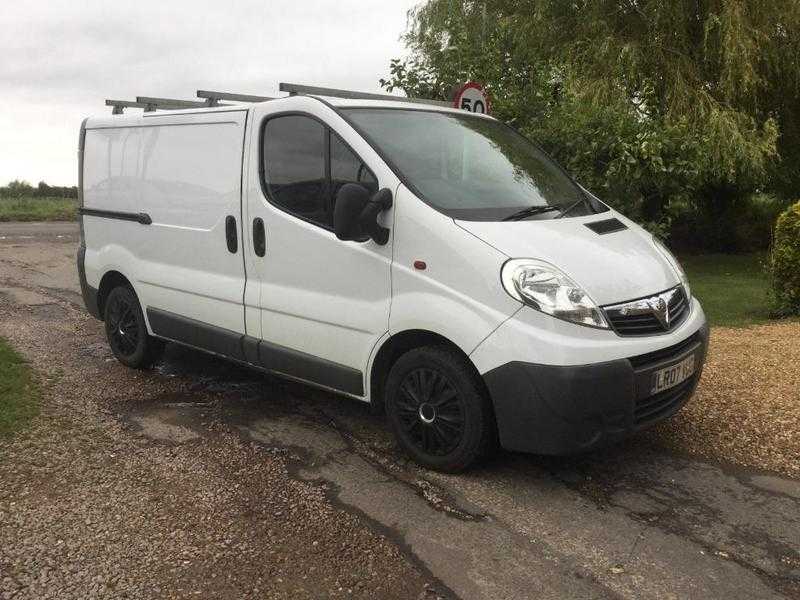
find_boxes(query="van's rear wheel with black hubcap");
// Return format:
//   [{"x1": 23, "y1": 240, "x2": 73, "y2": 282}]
[{"x1": 104, "y1": 286, "x2": 164, "y2": 369}]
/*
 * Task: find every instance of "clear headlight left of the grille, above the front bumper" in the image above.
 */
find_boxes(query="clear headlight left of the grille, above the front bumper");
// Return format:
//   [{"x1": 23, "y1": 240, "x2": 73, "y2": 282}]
[{"x1": 500, "y1": 258, "x2": 608, "y2": 329}]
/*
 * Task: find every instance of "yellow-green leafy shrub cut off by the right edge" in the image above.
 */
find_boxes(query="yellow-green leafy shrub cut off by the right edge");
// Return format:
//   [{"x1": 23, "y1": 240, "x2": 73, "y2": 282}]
[{"x1": 770, "y1": 202, "x2": 800, "y2": 316}]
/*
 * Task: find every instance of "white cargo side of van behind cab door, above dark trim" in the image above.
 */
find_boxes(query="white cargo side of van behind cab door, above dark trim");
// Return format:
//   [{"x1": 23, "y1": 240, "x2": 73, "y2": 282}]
[{"x1": 83, "y1": 110, "x2": 247, "y2": 332}]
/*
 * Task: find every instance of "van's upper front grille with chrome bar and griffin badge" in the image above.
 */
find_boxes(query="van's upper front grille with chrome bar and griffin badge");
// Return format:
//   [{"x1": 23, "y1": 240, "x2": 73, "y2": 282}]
[{"x1": 604, "y1": 285, "x2": 689, "y2": 336}]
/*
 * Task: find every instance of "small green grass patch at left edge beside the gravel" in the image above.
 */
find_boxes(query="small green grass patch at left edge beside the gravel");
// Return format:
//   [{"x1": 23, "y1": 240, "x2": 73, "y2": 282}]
[{"x1": 0, "y1": 338, "x2": 39, "y2": 437}]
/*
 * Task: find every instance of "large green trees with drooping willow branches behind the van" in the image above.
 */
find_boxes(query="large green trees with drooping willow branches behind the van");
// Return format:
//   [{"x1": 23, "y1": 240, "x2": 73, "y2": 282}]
[{"x1": 381, "y1": 0, "x2": 800, "y2": 247}]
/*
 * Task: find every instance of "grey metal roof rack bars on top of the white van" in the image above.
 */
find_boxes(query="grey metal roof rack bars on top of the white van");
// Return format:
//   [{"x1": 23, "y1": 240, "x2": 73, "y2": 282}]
[{"x1": 106, "y1": 83, "x2": 451, "y2": 115}]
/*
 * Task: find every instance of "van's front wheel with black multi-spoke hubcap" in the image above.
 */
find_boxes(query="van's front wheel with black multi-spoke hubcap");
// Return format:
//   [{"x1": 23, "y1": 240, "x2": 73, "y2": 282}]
[{"x1": 385, "y1": 346, "x2": 496, "y2": 473}]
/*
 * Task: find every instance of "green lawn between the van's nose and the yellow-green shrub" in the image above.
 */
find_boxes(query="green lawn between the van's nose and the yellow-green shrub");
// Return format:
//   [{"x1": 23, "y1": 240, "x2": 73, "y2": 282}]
[{"x1": 681, "y1": 253, "x2": 769, "y2": 327}]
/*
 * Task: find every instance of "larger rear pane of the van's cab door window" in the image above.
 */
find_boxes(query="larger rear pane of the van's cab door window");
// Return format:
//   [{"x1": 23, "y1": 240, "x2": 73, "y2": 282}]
[{"x1": 263, "y1": 115, "x2": 332, "y2": 226}]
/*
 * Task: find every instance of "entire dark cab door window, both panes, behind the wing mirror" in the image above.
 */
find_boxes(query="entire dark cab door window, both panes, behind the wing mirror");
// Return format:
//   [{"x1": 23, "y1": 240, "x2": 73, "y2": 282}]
[{"x1": 261, "y1": 115, "x2": 378, "y2": 229}]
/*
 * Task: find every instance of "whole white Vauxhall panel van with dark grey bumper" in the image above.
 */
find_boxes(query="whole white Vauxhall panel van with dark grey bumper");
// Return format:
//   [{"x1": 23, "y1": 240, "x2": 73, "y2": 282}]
[{"x1": 78, "y1": 88, "x2": 708, "y2": 471}]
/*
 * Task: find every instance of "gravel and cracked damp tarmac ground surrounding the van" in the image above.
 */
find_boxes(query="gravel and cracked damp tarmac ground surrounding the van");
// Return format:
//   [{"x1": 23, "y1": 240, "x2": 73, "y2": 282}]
[{"x1": 0, "y1": 225, "x2": 800, "y2": 599}]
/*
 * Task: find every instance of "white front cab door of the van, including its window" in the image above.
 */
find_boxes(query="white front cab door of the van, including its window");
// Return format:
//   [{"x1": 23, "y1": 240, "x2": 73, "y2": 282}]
[{"x1": 245, "y1": 98, "x2": 398, "y2": 396}]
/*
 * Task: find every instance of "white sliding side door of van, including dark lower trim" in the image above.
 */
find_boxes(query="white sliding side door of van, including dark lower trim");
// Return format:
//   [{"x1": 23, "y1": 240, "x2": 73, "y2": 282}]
[{"x1": 133, "y1": 110, "x2": 247, "y2": 357}]
